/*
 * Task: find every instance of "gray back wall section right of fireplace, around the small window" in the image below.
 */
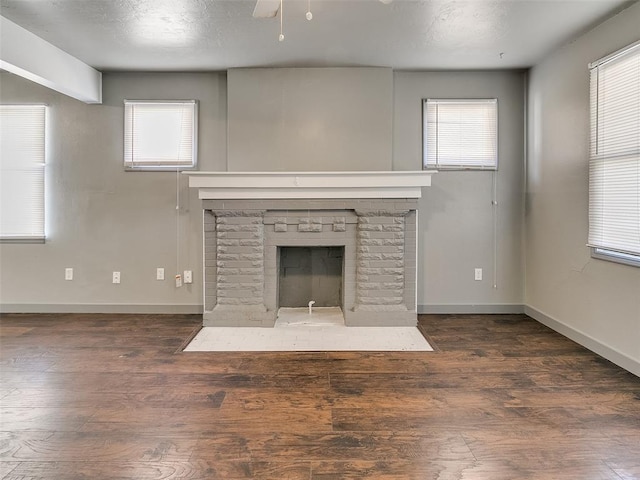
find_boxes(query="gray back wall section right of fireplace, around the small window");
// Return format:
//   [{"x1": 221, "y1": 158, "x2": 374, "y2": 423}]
[{"x1": 393, "y1": 72, "x2": 526, "y2": 313}]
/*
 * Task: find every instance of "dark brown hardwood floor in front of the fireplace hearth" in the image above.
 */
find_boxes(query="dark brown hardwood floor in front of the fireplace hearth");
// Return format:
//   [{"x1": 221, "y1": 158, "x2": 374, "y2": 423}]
[{"x1": 0, "y1": 314, "x2": 640, "y2": 480}]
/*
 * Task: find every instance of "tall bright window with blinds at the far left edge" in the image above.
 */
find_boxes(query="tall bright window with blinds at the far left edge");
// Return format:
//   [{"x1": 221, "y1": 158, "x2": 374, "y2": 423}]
[{"x1": 0, "y1": 105, "x2": 47, "y2": 243}]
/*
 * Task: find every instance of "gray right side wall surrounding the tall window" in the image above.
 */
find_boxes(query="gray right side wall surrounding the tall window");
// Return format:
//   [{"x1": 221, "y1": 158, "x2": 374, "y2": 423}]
[{"x1": 525, "y1": 3, "x2": 640, "y2": 375}]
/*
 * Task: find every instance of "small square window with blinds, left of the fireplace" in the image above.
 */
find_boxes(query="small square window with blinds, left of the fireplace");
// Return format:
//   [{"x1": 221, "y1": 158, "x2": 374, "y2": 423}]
[{"x1": 124, "y1": 100, "x2": 198, "y2": 170}]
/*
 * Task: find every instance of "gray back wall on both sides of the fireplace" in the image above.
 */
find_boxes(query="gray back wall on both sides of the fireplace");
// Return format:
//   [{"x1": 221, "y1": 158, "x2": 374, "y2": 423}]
[{"x1": 0, "y1": 69, "x2": 524, "y2": 312}]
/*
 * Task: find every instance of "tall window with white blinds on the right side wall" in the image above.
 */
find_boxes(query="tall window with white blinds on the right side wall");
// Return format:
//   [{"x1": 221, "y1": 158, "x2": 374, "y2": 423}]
[{"x1": 589, "y1": 42, "x2": 640, "y2": 266}]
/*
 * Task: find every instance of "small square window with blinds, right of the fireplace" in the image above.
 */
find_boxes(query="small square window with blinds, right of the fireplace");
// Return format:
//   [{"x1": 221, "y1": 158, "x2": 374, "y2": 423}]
[{"x1": 422, "y1": 98, "x2": 498, "y2": 170}]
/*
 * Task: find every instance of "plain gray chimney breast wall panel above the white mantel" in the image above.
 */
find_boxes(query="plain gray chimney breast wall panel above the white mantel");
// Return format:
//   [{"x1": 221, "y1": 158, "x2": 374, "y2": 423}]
[{"x1": 227, "y1": 68, "x2": 393, "y2": 172}]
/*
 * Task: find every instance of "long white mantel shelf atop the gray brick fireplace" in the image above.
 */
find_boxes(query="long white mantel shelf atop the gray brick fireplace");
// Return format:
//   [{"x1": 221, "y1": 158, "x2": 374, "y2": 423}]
[{"x1": 184, "y1": 170, "x2": 436, "y2": 200}]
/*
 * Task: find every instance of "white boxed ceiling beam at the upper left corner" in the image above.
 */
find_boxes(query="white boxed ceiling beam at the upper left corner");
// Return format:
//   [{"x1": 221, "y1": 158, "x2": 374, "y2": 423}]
[{"x1": 0, "y1": 16, "x2": 102, "y2": 103}]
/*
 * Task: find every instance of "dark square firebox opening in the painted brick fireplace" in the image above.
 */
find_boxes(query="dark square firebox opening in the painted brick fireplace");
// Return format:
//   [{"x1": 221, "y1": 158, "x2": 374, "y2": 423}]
[{"x1": 278, "y1": 246, "x2": 344, "y2": 308}]
